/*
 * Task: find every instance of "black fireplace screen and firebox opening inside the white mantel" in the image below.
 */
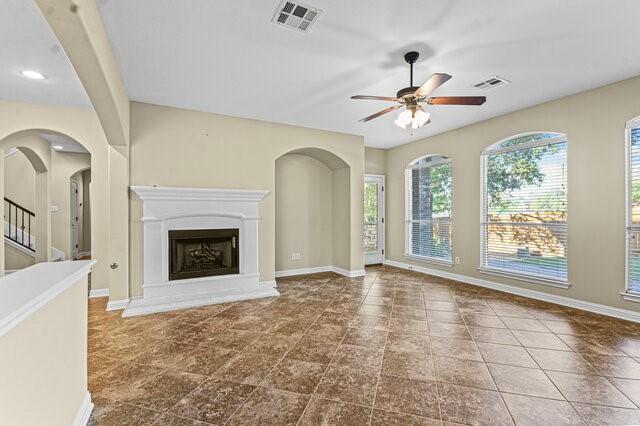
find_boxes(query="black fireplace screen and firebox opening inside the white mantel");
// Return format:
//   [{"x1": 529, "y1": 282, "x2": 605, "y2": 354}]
[{"x1": 169, "y1": 229, "x2": 240, "y2": 280}]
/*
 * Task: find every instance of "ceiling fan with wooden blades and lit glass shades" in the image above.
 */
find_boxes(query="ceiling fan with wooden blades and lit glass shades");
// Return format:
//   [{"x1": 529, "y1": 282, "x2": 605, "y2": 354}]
[{"x1": 351, "y1": 52, "x2": 487, "y2": 129}]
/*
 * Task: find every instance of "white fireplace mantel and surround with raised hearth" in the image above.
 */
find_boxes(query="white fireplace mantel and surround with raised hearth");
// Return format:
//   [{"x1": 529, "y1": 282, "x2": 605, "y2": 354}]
[{"x1": 123, "y1": 186, "x2": 279, "y2": 316}]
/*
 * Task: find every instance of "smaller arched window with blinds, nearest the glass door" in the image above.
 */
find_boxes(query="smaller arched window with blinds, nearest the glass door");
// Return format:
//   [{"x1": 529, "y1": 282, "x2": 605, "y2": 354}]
[{"x1": 405, "y1": 155, "x2": 452, "y2": 265}]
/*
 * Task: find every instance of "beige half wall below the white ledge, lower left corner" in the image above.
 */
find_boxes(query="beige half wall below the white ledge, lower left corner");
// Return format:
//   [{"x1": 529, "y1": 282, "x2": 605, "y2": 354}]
[{"x1": 0, "y1": 276, "x2": 87, "y2": 426}]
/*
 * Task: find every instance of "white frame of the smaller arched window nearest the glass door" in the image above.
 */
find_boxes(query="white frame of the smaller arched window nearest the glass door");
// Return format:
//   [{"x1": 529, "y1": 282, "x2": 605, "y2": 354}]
[{"x1": 404, "y1": 154, "x2": 455, "y2": 267}]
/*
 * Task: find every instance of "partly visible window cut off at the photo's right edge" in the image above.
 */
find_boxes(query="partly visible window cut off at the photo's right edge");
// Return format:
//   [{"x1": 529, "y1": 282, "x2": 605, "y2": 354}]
[{"x1": 626, "y1": 118, "x2": 640, "y2": 300}]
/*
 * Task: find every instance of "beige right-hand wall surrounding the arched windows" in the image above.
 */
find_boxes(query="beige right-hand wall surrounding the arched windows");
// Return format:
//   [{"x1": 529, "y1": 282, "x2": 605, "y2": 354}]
[{"x1": 386, "y1": 77, "x2": 640, "y2": 310}]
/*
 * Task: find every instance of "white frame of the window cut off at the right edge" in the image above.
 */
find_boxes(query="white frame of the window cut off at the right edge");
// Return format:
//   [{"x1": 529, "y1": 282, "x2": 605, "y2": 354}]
[{"x1": 620, "y1": 116, "x2": 640, "y2": 302}]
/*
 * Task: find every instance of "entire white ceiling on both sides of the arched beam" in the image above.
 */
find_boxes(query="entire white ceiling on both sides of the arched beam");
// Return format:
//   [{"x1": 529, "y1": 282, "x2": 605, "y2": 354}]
[{"x1": 0, "y1": 0, "x2": 640, "y2": 147}]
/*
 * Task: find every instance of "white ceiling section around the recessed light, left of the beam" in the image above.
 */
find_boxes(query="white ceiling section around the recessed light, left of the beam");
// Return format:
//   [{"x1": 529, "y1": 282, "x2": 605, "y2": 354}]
[{"x1": 0, "y1": 0, "x2": 91, "y2": 108}]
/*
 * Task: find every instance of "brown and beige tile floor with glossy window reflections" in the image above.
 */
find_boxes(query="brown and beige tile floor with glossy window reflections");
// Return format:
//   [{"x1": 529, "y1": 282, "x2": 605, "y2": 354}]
[{"x1": 89, "y1": 267, "x2": 640, "y2": 425}]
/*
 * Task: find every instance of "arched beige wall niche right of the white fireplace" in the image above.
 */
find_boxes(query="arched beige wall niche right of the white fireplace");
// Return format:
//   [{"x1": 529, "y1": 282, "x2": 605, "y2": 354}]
[{"x1": 275, "y1": 148, "x2": 352, "y2": 276}]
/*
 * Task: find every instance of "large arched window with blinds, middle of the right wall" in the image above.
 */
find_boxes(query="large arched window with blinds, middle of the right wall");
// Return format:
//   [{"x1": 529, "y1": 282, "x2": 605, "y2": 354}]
[{"x1": 480, "y1": 133, "x2": 568, "y2": 287}]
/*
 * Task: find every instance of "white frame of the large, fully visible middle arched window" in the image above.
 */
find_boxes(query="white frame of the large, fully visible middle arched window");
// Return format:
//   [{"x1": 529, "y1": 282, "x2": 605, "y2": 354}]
[{"x1": 478, "y1": 131, "x2": 571, "y2": 289}]
